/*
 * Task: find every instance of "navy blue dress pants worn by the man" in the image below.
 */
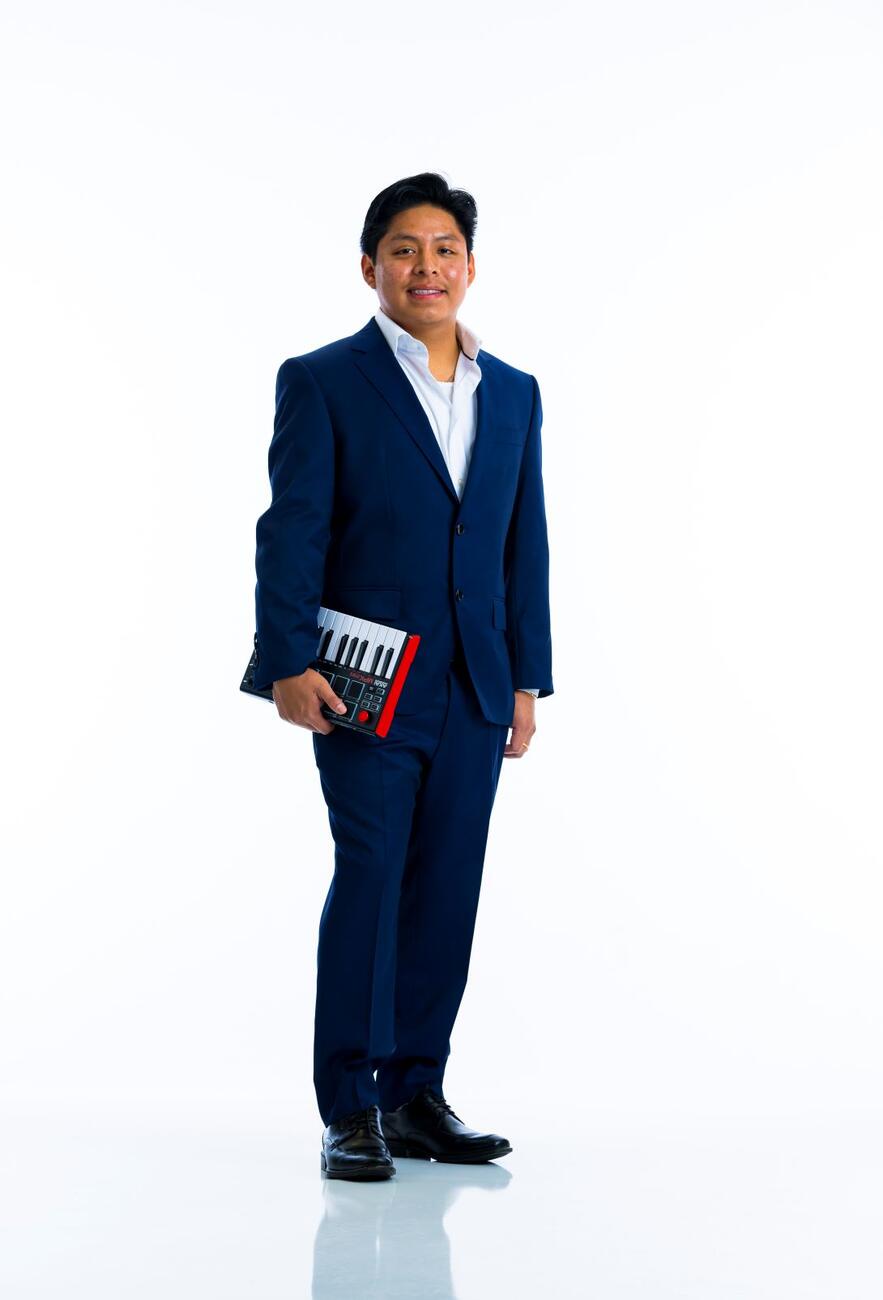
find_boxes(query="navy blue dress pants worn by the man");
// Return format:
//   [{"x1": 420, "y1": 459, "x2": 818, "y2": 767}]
[{"x1": 313, "y1": 651, "x2": 508, "y2": 1125}]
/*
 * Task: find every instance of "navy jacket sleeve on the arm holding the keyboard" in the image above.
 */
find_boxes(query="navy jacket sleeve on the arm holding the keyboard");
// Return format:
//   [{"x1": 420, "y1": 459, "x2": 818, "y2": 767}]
[{"x1": 255, "y1": 358, "x2": 334, "y2": 689}]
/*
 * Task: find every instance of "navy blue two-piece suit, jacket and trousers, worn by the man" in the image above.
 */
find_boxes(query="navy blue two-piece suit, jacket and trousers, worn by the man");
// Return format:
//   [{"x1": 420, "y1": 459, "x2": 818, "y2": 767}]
[{"x1": 255, "y1": 317, "x2": 553, "y2": 1123}]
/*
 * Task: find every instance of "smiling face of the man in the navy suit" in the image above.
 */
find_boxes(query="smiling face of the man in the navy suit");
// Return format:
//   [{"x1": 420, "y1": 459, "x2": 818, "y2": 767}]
[{"x1": 362, "y1": 203, "x2": 475, "y2": 332}]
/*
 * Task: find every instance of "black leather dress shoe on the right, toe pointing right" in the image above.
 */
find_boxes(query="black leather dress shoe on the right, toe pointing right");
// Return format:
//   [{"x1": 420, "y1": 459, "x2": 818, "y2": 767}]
[{"x1": 381, "y1": 1086, "x2": 512, "y2": 1165}]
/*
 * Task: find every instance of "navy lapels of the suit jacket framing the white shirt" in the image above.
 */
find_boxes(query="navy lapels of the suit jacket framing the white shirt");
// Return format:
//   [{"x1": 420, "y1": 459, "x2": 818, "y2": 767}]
[{"x1": 350, "y1": 316, "x2": 490, "y2": 504}]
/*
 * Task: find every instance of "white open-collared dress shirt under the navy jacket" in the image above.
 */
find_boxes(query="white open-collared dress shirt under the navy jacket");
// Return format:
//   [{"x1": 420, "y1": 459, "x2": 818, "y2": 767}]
[{"x1": 375, "y1": 306, "x2": 540, "y2": 696}]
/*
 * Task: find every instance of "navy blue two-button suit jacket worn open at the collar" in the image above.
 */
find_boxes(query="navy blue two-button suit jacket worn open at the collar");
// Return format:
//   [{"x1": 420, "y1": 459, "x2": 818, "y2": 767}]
[{"x1": 255, "y1": 310, "x2": 553, "y2": 725}]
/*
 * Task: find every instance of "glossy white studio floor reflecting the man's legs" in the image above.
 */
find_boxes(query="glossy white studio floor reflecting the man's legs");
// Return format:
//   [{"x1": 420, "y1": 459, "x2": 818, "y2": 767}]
[{"x1": 0, "y1": 1110, "x2": 883, "y2": 1300}]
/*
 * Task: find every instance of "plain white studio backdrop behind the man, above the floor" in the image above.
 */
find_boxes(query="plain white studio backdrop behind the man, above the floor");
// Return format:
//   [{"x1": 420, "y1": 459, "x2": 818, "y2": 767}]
[{"x1": 0, "y1": 0, "x2": 883, "y2": 1297}]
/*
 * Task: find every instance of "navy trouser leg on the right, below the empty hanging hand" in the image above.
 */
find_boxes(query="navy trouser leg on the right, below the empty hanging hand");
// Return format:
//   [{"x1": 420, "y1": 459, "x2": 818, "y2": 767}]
[{"x1": 377, "y1": 664, "x2": 508, "y2": 1110}]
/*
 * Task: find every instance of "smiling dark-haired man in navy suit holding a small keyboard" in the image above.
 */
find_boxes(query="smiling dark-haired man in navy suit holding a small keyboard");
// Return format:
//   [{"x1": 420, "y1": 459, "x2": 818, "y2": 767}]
[{"x1": 255, "y1": 172, "x2": 553, "y2": 1178}]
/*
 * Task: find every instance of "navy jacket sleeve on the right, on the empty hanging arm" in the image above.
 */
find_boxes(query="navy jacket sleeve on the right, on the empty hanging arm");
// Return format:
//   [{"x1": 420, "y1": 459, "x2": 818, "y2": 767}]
[{"x1": 503, "y1": 376, "x2": 554, "y2": 699}]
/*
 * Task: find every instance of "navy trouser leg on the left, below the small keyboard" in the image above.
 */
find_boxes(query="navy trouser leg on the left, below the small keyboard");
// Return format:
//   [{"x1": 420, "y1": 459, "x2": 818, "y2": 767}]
[{"x1": 312, "y1": 684, "x2": 447, "y2": 1125}]
